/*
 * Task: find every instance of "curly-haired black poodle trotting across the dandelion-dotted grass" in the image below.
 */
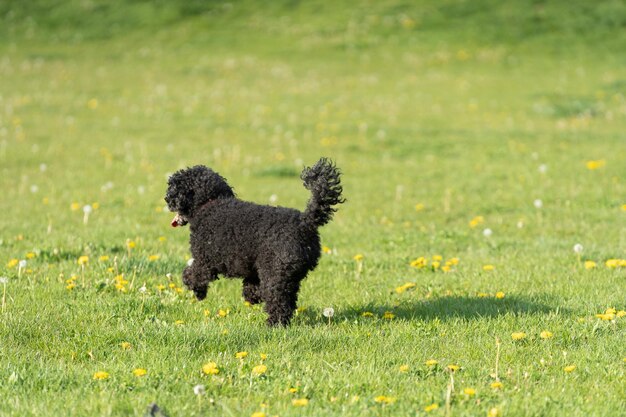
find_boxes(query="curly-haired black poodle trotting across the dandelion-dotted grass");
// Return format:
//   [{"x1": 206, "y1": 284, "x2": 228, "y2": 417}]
[{"x1": 165, "y1": 158, "x2": 344, "y2": 325}]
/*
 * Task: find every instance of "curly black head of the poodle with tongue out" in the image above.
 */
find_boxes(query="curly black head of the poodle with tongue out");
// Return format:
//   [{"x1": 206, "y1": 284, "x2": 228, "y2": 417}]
[{"x1": 165, "y1": 165, "x2": 235, "y2": 227}]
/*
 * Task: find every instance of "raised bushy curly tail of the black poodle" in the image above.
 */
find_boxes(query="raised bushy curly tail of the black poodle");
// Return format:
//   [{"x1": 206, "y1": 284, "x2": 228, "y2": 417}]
[{"x1": 300, "y1": 158, "x2": 345, "y2": 227}]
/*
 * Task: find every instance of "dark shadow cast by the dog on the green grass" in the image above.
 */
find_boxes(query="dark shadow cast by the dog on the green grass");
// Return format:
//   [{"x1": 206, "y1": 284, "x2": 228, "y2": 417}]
[{"x1": 299, "y1": 295, "x2": 565, "y2": 325}]
